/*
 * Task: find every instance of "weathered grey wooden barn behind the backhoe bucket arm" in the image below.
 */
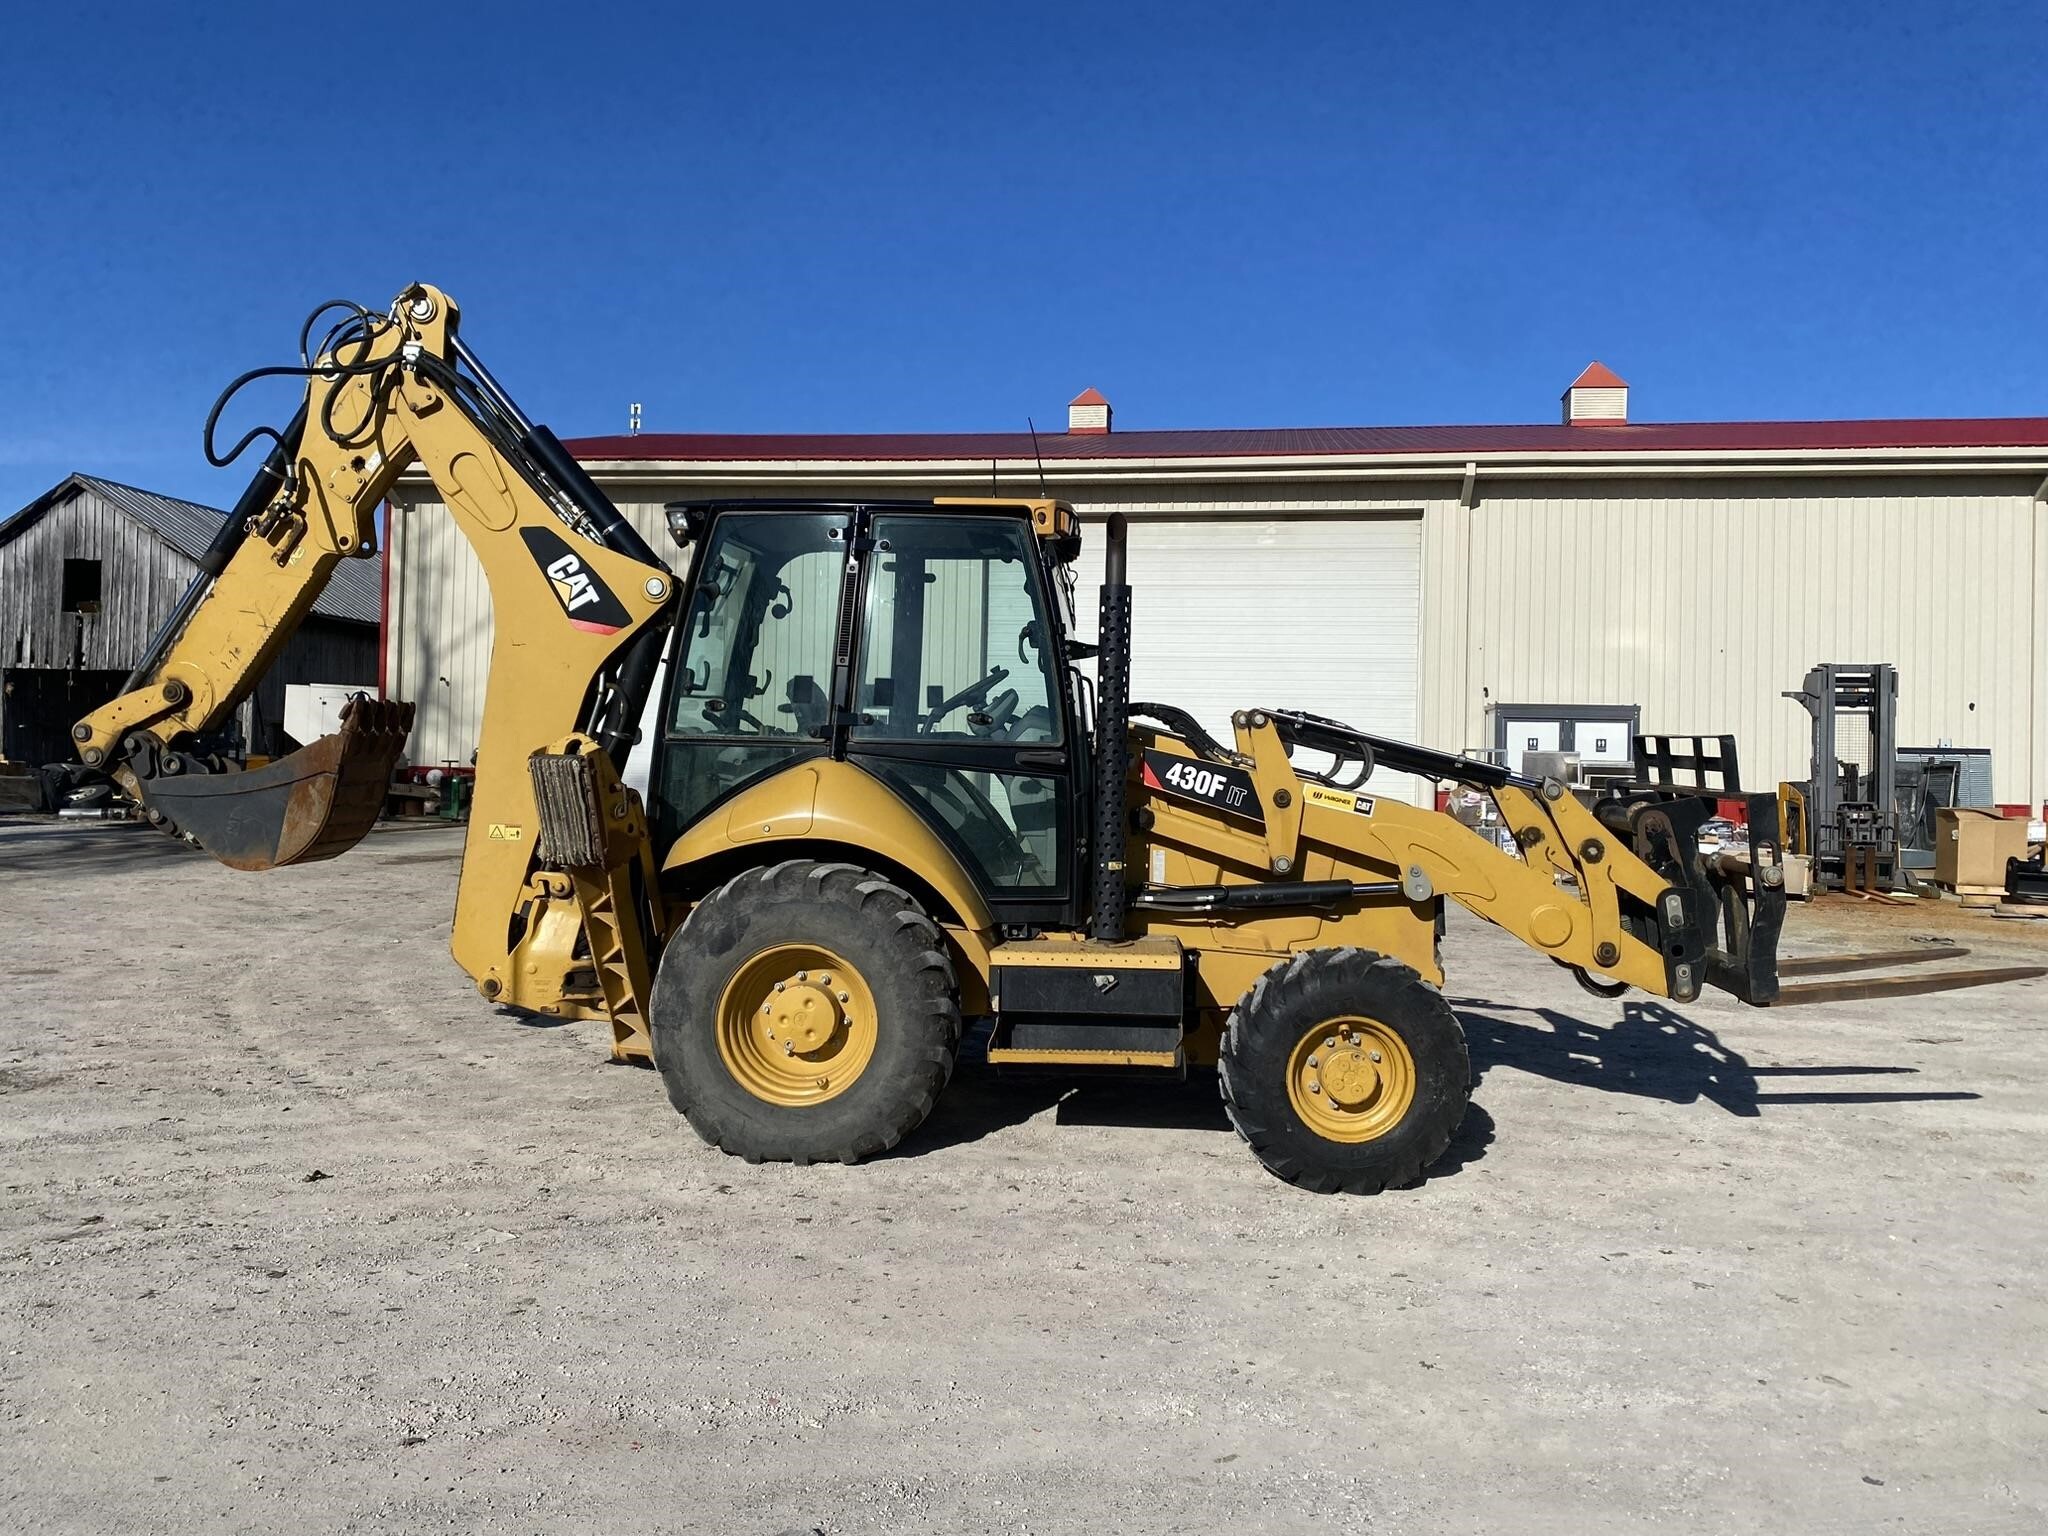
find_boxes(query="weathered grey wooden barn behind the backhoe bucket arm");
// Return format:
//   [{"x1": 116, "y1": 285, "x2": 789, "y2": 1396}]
[{"x1": 0, "y1": 475, "x2": 379, "y2": 764}]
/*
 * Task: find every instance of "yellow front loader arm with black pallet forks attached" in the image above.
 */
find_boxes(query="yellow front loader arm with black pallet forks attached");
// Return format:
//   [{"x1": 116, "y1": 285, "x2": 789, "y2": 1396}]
[{"x1": 1137, "y1": 705, "x2": 2048, "y2": 1008}]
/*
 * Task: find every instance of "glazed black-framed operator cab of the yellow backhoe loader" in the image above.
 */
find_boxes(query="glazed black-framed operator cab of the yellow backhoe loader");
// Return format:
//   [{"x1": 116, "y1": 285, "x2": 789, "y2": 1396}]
[{"x1": 647, "y1": 500, "x2": 1090, "y2": 924}]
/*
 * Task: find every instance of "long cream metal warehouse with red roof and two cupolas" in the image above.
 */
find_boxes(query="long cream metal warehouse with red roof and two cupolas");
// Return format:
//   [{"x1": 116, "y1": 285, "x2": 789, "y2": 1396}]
[{"x1": 385, "y1": 365, "x2": 2048, "y2": 807}]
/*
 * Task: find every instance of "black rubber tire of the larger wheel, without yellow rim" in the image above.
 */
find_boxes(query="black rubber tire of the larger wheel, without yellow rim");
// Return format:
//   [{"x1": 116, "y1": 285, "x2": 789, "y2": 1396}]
[{"x1": 649, "y1": 860, "x2": 961, "y2": 1163}]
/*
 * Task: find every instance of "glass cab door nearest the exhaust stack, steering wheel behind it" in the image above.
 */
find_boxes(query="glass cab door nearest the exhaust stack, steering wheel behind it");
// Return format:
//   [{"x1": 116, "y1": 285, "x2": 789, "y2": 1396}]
[{"x1": 846, "y1": 508, "x2": 1075, "y2": 924}]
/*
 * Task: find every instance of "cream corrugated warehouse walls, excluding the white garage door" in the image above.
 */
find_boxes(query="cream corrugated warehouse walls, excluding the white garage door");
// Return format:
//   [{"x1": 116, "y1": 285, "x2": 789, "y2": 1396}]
[{"x1": 389, "y1": 475, "x2": 2048, "y2": 803}]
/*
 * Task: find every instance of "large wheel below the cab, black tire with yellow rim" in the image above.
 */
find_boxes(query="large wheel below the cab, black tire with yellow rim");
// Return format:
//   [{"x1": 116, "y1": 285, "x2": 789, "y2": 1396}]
[{"x1": 651, "y1": 860, "x2": 961, "y2": 1163}]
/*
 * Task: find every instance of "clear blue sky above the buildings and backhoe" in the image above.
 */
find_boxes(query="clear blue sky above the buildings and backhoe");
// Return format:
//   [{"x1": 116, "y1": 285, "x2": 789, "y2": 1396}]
[{"x1": 0, "y1": 0, "x2": 2048, "y2": 512}]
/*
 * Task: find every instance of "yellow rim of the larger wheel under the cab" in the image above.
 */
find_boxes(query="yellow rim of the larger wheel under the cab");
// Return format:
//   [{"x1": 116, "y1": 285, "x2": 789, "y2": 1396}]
[{"x1": 719, "y1": 944, "x2": 879, "y2": 1108}]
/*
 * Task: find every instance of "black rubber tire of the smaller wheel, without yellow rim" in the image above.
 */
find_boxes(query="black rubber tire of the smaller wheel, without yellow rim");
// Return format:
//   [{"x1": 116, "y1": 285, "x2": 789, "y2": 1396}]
[{"x1": 1217, "y1": 948, "x2": 1473, "y2": 1194}]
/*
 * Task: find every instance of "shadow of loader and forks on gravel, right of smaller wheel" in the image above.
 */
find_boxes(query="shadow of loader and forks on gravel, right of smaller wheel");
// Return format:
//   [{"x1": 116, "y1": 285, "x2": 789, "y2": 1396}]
[{"x1": 1452, "y1": 997, "x2": 1980, "y2": 1116}]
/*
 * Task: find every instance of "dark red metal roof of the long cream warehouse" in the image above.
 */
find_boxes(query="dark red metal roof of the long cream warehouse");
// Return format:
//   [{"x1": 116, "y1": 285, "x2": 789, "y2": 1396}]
[{"x1": 567, "y1": 416, "x2": 2048, "y2": 463}]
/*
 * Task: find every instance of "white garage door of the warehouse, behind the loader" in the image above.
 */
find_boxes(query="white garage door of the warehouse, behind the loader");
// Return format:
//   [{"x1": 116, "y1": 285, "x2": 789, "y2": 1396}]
[{"x1": 1075, "y1": 514, "x2": 1421, "y2": 799}]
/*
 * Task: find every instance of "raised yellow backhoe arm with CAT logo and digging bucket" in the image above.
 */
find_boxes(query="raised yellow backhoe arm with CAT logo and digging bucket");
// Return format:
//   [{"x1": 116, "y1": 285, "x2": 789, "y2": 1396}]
[{"x1": 74, "y1": 285, "x2": 676, "y2": 1036}]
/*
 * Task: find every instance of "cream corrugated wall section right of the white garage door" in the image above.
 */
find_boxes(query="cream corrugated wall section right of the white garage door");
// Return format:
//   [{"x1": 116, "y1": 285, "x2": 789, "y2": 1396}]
[{"x1": 1462, "y1": 477, "x2": 2042, "y2": 801}]
